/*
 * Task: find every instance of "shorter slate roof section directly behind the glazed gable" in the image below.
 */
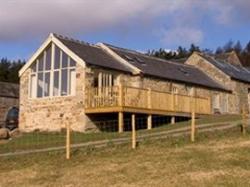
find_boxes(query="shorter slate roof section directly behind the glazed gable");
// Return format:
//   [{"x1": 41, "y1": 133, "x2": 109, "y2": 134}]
[{"x1": 54, "y1": 34, "x2": 132, "y2": 73}]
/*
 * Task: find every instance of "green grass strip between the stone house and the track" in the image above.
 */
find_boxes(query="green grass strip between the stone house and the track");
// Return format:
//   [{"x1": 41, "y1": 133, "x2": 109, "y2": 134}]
[{"x1": 0, "y1": 115, "x2": 241, "y2": 153}]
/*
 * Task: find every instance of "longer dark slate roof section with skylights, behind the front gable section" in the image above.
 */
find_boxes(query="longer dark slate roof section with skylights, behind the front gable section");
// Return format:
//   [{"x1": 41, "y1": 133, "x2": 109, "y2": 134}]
[{"x1": 105, "y1": 44, "x2": 227, "y2": 90}]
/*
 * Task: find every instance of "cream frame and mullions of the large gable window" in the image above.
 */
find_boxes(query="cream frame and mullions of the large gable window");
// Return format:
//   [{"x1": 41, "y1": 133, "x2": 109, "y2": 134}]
[{"x1": 28, "y1": 43, "x2": 77, "y2": 99}]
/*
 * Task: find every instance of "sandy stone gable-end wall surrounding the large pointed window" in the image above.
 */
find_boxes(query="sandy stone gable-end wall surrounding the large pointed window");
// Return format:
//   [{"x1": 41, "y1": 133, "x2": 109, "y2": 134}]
[{"x1": 19, "y1": 64, "x2": 91, "y2": 131}]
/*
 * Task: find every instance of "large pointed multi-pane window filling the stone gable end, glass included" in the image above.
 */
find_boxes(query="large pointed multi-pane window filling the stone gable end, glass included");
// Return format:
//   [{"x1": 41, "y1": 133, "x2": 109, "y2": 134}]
[{"x1": 30, "y1": 46, "x2": 76, "y2": 98}]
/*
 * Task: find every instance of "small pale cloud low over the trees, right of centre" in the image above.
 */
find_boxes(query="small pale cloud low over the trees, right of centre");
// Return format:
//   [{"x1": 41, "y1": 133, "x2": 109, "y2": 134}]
[{"x1": 161, "y1": 27, "x2": 203, "y2": 46}]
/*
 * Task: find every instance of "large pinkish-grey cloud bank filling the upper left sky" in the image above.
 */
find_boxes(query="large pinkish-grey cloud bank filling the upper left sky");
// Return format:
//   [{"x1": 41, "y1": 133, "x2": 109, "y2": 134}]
[{"x1": 0, "y1": 0, "x2": 184, "y2": 39}]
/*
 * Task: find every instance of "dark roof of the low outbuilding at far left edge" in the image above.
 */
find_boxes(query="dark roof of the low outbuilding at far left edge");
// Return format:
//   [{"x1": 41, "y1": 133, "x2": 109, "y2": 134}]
[{"x1": 0, "y1": 82, "x2": 19, "y2": 98}]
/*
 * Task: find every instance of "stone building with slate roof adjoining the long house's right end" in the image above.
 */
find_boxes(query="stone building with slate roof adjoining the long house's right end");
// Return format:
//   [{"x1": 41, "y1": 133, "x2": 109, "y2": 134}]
[{"x1": 186, "y1": 52, "x2": 250, "y2": 113}]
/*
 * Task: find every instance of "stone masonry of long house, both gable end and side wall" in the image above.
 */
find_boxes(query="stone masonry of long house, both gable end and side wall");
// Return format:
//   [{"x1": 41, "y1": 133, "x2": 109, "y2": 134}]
[{"x1": 19, "y1": 64, "x2": 232, "y2": 132}]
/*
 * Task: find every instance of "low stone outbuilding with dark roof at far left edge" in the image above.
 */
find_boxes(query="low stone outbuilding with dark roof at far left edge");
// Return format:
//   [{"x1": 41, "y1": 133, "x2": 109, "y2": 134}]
[{"x1": 0, "y1": 82, "x2": 19, "y2": 126}]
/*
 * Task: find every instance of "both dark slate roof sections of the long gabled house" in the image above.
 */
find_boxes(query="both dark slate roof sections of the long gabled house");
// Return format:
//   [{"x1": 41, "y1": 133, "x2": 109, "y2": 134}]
[{"x1": 54, "y1": 34, "x2": 227, "y2": 90}]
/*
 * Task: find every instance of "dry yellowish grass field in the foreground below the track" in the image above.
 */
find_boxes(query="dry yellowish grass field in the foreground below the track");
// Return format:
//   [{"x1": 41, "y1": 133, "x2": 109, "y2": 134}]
[{"x1": 0, "y1": 125, "x2": 250, "y2": 187}]
